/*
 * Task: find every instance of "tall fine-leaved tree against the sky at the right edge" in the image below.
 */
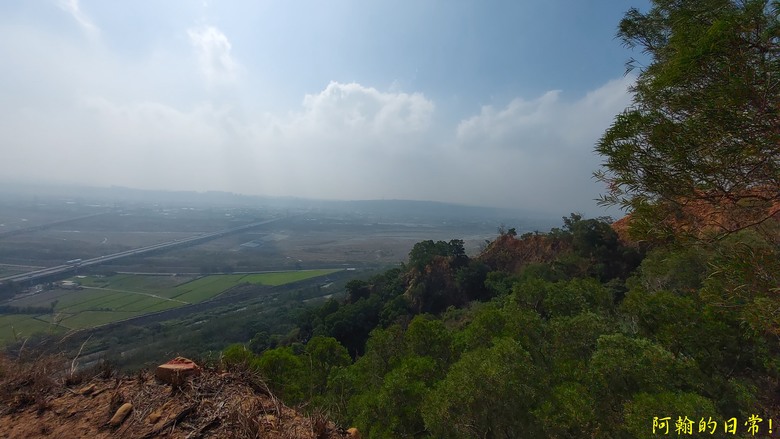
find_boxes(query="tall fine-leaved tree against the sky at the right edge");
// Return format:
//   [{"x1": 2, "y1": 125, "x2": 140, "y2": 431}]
[{"x1": 596, "y1": 0, "x2": 780, "y2": 241}]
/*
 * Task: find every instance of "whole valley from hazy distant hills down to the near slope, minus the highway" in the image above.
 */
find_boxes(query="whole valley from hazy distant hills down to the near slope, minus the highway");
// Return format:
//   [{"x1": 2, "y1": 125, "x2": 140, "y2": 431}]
[{"x1": 0, "y1": 186, "x2": 544, "y2": 372}]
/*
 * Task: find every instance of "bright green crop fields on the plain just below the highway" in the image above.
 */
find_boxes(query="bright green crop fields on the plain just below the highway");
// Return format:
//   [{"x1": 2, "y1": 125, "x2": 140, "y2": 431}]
[{"x1": 0, "y1": 269, "x2": 341, "y2": 345}]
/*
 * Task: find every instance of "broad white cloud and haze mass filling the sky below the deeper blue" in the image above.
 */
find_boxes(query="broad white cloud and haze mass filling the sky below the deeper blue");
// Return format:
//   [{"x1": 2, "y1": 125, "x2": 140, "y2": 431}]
[{"x1": 0, "y1": 0, "x2": 644, "y2": 218}]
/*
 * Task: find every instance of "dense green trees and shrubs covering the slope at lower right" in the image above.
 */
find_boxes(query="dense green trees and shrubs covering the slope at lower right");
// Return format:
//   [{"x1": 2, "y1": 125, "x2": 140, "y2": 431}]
[{"x1": 223, "y1": 223, "x2": 779, "y2": 438}]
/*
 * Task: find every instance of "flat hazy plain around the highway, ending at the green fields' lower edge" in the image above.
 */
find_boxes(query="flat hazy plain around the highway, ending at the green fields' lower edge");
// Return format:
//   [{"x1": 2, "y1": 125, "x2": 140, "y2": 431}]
[{"x1": 0, "y1": 195, "x2": 524, "y2": 346}]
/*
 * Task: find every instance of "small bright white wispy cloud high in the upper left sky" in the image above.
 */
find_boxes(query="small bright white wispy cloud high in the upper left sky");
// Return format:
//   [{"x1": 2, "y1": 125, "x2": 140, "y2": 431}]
[{"x1": 187, "y1": 26, "x2": 239, "y2": 84}]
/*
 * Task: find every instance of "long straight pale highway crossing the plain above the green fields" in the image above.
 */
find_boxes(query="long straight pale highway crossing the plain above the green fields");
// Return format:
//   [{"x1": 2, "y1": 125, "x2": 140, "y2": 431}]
[{"x1": 0, "y1": 217, "x2": 289, "y2": 284}]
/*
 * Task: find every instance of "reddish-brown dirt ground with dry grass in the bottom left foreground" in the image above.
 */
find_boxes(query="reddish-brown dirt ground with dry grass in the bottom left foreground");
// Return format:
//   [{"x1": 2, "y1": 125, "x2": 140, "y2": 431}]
[{"x1": 0, "y1": 357, "x2": 349, "y2": 439}]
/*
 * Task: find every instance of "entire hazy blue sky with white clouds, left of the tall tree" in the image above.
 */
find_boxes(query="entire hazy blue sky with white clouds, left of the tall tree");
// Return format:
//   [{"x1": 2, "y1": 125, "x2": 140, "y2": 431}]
[{"x1": 0, "y1": 0, "x2": 646, "y2": 215}]
